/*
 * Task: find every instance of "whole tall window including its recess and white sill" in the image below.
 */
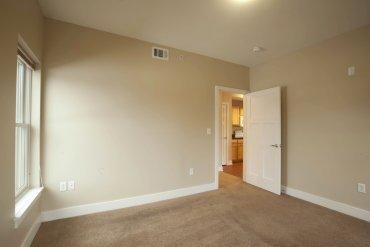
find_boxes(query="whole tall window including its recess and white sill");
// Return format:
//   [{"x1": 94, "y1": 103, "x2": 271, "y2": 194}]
[{"x1": 14, "y1": 42, "x2": 43, "y2": 228}]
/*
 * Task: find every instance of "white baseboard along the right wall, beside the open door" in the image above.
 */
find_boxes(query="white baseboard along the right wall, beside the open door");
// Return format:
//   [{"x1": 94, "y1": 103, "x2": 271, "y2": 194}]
[{"x1": 282, "y1": 186, "x2": 370, "y2": 222}]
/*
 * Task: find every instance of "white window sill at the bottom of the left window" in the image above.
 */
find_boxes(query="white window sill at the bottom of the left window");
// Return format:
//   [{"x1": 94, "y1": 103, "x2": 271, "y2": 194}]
[{"x1": 14, "y1": 187, "x2": 44, "y2": 228}]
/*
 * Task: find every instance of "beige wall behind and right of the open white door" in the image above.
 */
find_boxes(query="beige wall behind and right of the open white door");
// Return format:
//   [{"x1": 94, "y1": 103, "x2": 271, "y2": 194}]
[{"x1": 250, "y1": 26, "x2": 370, "y2": 210}]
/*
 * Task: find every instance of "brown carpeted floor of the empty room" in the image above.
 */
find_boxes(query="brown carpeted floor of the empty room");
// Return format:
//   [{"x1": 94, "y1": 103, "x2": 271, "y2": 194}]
[{"x1": 32, "y1": 173, "x2": 370, "y2": 247}]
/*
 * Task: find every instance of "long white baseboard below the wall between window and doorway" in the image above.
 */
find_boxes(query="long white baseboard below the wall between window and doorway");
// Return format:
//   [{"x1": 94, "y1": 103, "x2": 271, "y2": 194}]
[{"x1": 41, "y1": 183, "x2": 217, "y2": 222}]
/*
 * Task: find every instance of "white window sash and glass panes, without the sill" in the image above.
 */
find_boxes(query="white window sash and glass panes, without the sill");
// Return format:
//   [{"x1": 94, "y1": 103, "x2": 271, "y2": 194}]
[{"x1": 15, "y1": 56, "x2": 33, "y2": 197}]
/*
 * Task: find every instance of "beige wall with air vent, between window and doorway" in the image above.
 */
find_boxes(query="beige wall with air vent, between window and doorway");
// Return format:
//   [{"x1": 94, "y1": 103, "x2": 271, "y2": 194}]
[{"x1": 42, "y1": 20, "x2": 249, "y2": 210}]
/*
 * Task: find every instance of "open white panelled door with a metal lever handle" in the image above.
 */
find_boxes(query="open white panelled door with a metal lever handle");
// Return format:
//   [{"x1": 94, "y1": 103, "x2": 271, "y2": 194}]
[{"x1": 243, "y1": 87, "x2": 281, "y2": 195}]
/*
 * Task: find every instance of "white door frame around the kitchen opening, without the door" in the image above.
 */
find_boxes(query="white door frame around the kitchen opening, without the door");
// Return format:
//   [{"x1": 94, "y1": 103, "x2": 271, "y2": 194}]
[{"x1": 214, "y1": 85, "x2": 249, "y2": 188}]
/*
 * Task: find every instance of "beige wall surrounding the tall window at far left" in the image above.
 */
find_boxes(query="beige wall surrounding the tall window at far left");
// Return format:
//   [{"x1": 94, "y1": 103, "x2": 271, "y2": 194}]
[{"x1": 0, "y1": 0, "x2": 43, "y2": 246}]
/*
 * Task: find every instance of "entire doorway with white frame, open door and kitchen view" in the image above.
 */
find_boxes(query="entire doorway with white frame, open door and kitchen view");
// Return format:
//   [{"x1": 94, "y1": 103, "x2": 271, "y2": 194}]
[{"x1": 215, "y1": 86, "x2": 281, "y2": 194}]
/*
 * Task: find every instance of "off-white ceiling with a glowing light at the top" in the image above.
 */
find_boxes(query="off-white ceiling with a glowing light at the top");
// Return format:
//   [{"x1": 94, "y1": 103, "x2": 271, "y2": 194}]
[{"x1": 39, "y1": 0, "x2": 370, "y2": 66}]
